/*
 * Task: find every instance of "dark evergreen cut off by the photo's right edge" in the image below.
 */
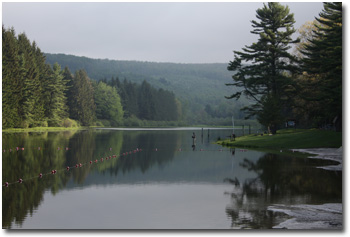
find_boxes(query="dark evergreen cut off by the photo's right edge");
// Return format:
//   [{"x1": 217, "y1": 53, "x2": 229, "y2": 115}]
[{"x1": 301, "y1": 2, "x2": 343, "y2": 130}]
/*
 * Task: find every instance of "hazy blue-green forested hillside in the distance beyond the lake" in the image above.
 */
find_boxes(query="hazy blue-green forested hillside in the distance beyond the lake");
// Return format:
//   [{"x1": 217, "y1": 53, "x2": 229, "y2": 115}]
[{"x1": 45, "y1": 54, "x2": 252, "y2": 125}]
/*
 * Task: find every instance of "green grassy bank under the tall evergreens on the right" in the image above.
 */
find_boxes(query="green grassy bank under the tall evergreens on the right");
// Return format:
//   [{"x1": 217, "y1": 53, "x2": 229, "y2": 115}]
[{"x1": 217, "y1": 129, "x2": 342, "y2": 150}]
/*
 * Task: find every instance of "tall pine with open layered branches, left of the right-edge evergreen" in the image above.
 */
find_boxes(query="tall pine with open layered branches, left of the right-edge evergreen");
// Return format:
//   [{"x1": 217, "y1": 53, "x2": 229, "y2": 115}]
[{"x1": 226, "y1": 2, "x2": 298, "y2": 133}]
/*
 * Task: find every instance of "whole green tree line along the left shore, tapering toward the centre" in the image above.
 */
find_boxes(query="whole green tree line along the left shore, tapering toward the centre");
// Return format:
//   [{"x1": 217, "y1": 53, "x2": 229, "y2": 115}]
[{"x1": 2, "y1": 26, "x2": 181, "y2": 129}]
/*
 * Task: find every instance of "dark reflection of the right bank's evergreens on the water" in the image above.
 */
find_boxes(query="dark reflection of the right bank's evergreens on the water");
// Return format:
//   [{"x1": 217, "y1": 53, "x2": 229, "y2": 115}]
[{"x1": 224, "y1": 154, "x2": 342, "y2": 229}]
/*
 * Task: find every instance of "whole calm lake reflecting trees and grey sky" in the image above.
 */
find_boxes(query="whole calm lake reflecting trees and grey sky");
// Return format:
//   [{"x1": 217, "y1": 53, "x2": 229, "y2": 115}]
[{"x1": 2, "y1": 128, "x2": 343, "y2": 229}]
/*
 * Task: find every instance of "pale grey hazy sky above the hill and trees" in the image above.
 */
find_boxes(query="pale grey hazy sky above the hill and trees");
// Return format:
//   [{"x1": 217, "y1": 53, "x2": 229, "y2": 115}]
[{"x1": 2, "y1": 2, "x2": 323, "y2": 63}]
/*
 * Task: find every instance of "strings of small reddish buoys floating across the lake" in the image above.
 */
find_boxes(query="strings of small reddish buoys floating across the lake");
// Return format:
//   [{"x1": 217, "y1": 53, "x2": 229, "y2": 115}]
[{"x1": 3, "y1": 147, "x2": 248, "y2": 187}]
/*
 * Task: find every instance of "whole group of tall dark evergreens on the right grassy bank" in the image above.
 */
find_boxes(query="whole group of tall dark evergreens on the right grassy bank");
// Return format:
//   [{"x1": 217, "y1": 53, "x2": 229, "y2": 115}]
[{"x1": 227, "y1": 2, "x2": 342, "y2": 133}]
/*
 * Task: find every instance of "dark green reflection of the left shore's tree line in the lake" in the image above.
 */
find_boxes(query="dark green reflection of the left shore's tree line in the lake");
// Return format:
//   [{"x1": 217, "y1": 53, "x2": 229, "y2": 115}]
[{"x1": 2, "y1": 130, "x2": 177, "y2": 228}]
